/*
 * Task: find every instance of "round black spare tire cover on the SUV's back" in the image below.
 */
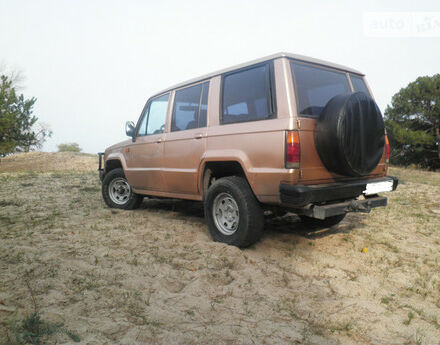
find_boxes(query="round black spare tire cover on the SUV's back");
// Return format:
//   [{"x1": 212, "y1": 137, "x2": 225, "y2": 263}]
[{"x1": 315, "y1": 92, "x2": 385, "y2": 176}]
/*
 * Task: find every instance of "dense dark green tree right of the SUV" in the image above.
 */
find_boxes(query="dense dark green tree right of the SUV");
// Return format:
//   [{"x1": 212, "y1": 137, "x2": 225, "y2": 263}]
[{"x1": 385, "y1": 74, "x2": 440, "y2": 170}]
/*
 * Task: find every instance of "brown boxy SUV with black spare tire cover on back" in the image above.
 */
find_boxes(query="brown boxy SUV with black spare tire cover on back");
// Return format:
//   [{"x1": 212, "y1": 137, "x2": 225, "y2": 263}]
[{"x1": 99, "y1": 53, "x2": 398, "y2": 247}]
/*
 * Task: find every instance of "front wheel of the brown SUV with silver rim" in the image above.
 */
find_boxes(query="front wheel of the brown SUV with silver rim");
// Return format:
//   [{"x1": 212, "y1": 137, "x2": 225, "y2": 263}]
[{"x1": 102, "y1": 168, "x2": 144, "y2": 210}]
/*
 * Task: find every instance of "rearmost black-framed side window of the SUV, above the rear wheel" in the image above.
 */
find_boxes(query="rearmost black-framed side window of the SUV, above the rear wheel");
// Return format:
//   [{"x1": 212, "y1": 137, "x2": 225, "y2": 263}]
[{"x1": 222, "y1": 64, "x2": 274, "y2": 123}]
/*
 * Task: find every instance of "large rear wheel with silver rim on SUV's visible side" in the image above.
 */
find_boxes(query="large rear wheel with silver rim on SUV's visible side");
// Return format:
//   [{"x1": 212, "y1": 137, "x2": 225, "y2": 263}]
[{"x1": 204, "y1": 176, "x2": 264, "y2": 248}]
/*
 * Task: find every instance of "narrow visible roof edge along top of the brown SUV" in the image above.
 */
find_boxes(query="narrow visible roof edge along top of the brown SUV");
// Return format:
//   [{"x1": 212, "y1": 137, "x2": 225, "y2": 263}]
[{"x1": 153, "y1": 52, "x2": 364, "y2": 97}]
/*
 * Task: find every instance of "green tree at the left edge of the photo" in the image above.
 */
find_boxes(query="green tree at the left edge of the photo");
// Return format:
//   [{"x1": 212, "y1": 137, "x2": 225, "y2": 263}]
[{"x1": 0, "y1": 75, "x2": 52, "y2": 157}]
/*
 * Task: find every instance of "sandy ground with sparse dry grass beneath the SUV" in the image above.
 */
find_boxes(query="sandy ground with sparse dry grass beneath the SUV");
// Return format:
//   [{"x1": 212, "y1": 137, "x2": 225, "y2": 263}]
[{"x1": 0, "y1": 154, "x2": 440, "y2": 344}]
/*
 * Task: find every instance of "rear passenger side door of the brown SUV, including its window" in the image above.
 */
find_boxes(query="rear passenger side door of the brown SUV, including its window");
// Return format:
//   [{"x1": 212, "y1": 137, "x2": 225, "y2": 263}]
[{"x1": 163, "y1": 81, "x2": 209, "y2": 195}]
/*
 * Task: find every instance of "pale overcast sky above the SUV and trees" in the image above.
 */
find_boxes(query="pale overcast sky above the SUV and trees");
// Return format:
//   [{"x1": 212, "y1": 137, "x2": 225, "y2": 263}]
[{"x1": 0, "y1": 0, "x2": 440, "y2": 153}]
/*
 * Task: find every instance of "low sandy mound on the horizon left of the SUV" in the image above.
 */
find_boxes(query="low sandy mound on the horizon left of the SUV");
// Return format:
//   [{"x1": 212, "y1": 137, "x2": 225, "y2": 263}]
[{"x1": 0, "y1": 152, "x2": 98, "y2": 171}]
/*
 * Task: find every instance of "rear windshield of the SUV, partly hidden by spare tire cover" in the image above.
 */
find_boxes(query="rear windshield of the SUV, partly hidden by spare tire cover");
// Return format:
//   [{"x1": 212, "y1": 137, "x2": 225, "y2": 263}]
[{"x1": 291, "y1": 61, "x2": 351, "y2": 116}]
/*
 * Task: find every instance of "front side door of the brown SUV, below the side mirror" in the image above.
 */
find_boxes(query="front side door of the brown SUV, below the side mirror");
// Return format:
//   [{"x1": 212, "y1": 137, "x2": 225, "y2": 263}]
[{"x1": 125, "y1": 93, "x2": 169, "y2": 191}]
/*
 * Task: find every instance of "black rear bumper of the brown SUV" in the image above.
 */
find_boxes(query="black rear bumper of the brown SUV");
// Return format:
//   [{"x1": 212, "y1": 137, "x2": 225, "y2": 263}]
[{"x1": 280, "y1": 176, "x2": 399, "y2": 207}]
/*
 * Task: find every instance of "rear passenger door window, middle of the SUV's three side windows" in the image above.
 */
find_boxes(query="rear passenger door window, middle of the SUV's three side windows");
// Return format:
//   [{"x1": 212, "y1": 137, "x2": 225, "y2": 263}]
[{"x1": 171, "y1": 82, "x2": 209, "y2": 132}]
